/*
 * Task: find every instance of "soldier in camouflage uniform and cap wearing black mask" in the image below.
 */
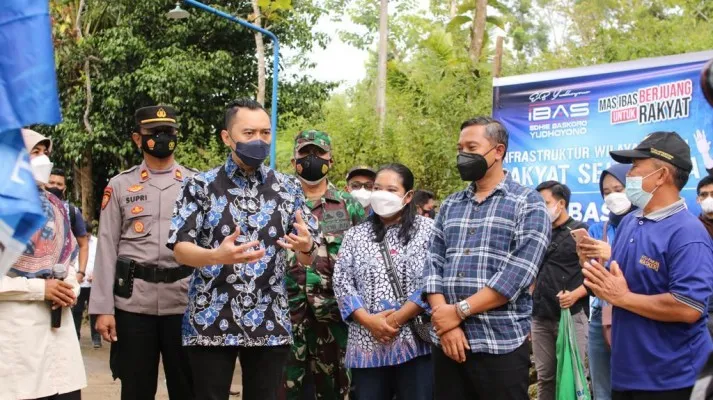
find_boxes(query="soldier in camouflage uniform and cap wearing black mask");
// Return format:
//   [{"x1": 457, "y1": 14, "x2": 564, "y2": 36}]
[{"x1": 285, "y1": 130, "x2": 365, "y2": 399}]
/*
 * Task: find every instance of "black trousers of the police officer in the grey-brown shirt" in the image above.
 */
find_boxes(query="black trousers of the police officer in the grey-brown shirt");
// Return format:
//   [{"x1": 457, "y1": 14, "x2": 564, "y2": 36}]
[{"x1": 110, "y1": 310, "x2": 194, "y2": 400}]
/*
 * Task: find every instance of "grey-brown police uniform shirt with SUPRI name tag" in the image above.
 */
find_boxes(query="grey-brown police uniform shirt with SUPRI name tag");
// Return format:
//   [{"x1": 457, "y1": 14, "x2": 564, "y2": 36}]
[{"x1": 89, "y1": 163, "x2": 194, "y2": 315}]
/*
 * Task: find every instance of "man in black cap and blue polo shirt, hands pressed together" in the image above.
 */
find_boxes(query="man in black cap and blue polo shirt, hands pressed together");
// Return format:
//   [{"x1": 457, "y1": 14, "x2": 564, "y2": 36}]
[{"x1": 584, "y1": 132, "x2": 713, "y2": 400}]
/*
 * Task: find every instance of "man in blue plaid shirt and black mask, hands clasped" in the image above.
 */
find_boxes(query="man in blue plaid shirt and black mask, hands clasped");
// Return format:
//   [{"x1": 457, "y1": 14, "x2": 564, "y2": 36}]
[{"x1": 424, "y1": 117, "x2": 551, "y2": 400}]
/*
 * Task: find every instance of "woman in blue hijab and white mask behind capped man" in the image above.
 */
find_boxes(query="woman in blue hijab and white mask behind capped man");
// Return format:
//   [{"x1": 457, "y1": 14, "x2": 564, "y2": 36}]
[{"x1": 577, "y1": 164, "x2": 635, "y2": 400}]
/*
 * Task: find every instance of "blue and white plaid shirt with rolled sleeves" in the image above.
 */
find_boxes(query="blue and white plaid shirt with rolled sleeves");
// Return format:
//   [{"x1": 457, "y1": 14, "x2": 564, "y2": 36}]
[{"x1": 423, "y1": 175, "x2": 551, "y2": 354}]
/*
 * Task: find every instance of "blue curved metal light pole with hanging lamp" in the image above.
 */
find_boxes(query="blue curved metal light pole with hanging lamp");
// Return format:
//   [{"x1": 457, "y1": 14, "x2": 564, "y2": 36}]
[{"x1": 167, "y1": 0, "x2": 280, "y2": 168}]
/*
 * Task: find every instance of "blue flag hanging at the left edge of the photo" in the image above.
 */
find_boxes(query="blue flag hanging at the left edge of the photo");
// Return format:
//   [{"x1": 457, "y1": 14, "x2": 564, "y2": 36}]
[{"x1": 0, "y1": 0, "x2": 61, "y2": 276}]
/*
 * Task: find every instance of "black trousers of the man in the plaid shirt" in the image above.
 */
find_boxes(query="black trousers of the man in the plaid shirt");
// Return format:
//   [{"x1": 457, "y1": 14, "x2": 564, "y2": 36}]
[{"x1": 432, "y1": 342, "x2": 530, "y2": 400}]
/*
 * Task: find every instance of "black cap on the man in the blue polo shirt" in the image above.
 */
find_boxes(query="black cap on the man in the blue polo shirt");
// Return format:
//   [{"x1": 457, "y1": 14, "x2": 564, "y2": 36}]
[{"x1": 609, "y1": 132, "x2": 693, "y2": 172}]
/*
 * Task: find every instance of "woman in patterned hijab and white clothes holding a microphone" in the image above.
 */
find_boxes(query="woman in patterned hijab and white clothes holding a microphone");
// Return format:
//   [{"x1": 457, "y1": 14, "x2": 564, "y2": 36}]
[{"x1": 0, "y1": 129, "x2": 87, "y2": 400}]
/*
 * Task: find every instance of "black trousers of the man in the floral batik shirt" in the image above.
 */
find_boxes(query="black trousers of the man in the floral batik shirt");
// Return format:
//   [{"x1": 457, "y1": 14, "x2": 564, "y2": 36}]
[{"x1": 186, "y1": 346, "x2": 290, "y2": 400}]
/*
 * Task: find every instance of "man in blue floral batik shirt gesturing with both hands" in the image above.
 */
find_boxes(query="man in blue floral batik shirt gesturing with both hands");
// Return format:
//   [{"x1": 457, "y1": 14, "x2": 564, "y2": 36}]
[{"x1": 168, "y1": 100, "x2": 319, "y2": 400}]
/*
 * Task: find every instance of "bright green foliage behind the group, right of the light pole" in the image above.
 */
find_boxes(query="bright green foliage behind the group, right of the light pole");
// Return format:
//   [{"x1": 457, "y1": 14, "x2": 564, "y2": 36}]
[{"x1": 278, "y1": 0, "x2": 713, "y2": 198}]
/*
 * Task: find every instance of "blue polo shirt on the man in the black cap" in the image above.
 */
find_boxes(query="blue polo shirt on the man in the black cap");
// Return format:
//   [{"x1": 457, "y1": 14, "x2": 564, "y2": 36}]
[{"x1": 611, "y1": 200, "x2": 713, "y2": 391}]
